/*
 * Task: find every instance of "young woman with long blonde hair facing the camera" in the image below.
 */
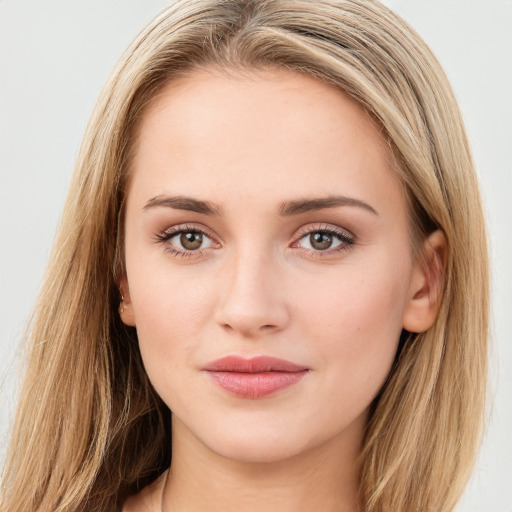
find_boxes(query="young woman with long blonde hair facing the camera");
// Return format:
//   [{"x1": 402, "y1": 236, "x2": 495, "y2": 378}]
[{"x1": 2, "y1": 0, "x2": 488, "y2": 511}]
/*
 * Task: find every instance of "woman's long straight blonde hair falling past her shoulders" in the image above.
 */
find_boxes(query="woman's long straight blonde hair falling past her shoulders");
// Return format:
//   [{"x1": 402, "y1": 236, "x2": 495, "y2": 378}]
[{"x1": 0, "y1": 0, "x2": 489, "y2": 512}]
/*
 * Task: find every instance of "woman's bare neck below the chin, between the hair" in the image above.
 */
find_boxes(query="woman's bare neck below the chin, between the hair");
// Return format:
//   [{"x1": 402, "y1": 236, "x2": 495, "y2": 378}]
[{"x1": 162, "y1": 416, "x2": 362, "y2": 512}]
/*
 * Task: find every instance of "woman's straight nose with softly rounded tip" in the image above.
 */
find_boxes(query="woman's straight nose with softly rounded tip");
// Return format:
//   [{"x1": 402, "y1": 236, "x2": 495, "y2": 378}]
[{"x1": 216, "y1": 249, "x2": 289, "y2": 338}]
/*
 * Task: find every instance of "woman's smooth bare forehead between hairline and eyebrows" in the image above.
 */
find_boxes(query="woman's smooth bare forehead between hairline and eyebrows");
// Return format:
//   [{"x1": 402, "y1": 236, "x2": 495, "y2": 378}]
[{"x1": 130, "y1": 65, "x2": 400, "y2": 214}]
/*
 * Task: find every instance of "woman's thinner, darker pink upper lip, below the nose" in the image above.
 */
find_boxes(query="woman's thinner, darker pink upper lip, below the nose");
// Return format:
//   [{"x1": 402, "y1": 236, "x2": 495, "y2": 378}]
[{"x1": 202, "y1": 355, "x2": 308, "y2": 373}]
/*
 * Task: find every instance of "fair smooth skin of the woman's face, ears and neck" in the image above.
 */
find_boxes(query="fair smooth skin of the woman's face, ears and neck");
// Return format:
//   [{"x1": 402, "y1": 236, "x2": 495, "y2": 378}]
[{"x1": 120, "y1": 69, "x2": 445, "y2": 512}]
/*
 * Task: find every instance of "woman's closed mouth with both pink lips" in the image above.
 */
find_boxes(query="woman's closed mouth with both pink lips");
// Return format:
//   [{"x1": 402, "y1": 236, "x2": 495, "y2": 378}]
[{"x1": 202, "y1": 356, "x2": 309, "y2": 399}]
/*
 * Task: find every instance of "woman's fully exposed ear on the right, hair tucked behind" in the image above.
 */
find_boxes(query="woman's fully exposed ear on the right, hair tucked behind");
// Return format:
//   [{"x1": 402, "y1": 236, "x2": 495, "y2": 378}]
[{"x1": 403, "y1": 230, "x2": 447, "y2": 332}]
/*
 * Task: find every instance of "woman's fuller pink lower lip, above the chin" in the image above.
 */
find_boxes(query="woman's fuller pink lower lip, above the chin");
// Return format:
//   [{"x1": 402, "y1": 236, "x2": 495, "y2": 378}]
[{"x1": 208, "y1": 370, "x2": 308, "y2": 399}]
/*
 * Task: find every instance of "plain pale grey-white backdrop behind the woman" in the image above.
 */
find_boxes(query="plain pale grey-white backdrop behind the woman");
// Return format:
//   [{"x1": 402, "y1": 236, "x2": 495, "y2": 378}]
[{"x1": 0, "y1": 0, "x2": 512, "y2": 512}]
